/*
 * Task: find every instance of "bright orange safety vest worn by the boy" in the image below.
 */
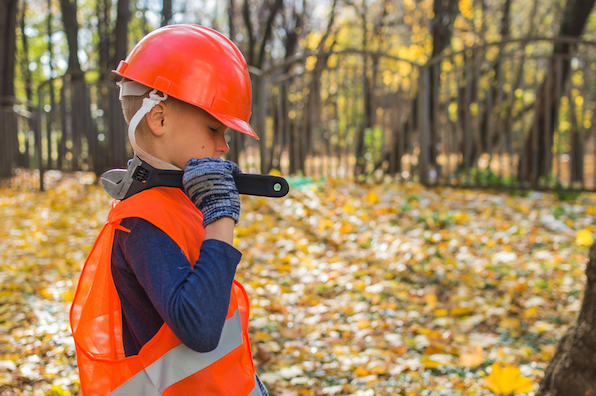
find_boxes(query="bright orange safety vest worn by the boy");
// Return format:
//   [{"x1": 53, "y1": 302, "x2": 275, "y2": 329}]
[{"x1": 70, "y1": 187, "x2": 261, "y2": 396}]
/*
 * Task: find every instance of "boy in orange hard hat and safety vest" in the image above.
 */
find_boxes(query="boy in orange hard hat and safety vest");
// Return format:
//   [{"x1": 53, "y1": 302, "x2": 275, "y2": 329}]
[{"x1": 71, "y1": 25, "x2": 267, "y2": 396}]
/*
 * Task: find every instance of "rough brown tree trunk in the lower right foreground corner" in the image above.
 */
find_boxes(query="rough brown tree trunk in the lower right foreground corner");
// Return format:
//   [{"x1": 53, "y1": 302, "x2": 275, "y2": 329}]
[{"x1": 536, "y1": 244, "x2": 596, "y2": 396}]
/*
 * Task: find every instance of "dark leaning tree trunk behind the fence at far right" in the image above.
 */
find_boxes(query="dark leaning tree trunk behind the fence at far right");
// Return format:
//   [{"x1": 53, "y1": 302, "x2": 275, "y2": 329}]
[{"x1": 518, "y1": 0, "x2": 595, "y2": 186}]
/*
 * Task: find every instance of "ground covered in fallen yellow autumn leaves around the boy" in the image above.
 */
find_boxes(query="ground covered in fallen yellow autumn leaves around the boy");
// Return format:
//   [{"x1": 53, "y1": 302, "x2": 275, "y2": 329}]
[{"x1": 0, "y1": 173, "x2": 596, "y2": 396}]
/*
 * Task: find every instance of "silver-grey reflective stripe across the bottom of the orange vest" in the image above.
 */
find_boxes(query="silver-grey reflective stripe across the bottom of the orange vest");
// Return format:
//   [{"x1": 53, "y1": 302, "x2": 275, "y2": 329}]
[{"x1": 110, "y1": 310, "x2": 261, "y2": 396}]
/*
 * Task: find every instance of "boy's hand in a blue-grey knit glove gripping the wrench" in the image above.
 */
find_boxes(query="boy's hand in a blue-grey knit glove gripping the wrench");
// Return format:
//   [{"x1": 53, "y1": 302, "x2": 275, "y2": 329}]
[{"x1": 182, "y1": 157, "x2": 241, "y2": 227}]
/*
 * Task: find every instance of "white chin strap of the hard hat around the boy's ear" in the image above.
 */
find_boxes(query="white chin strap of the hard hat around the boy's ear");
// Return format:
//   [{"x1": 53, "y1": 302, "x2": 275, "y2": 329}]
[{"x1": 119, "y1": 81, "x2": 181, "y2": 170}]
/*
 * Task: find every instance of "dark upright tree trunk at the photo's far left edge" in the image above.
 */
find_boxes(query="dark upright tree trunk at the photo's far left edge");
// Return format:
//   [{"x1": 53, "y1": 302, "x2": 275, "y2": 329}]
[{"x1": 0, "y1": 0, "x2": 18, "y2": 178}]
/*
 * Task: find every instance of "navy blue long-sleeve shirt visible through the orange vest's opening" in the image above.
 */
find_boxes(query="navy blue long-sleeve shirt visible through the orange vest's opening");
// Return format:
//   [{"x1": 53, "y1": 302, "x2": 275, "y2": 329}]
[{"x1": 112, "y1": 217, "x2": 242, "y2": 356}]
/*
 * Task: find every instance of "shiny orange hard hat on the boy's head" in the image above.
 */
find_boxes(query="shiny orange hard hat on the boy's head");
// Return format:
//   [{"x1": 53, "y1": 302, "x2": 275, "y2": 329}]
[{"x1": 113, "y1": 25, "x2": 259, "y2": 139}]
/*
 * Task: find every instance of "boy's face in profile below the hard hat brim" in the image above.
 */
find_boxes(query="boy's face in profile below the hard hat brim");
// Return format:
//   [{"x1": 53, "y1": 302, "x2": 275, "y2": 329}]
[{"x1": 151, "y1": 100, "x2": 230, "y2": 169}]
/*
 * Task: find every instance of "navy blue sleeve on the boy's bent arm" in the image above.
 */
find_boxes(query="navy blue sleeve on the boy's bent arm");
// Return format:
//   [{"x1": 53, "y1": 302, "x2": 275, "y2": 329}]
[{"x1": 119, "y1": 218, "x2": 242, "y2": 352}]
